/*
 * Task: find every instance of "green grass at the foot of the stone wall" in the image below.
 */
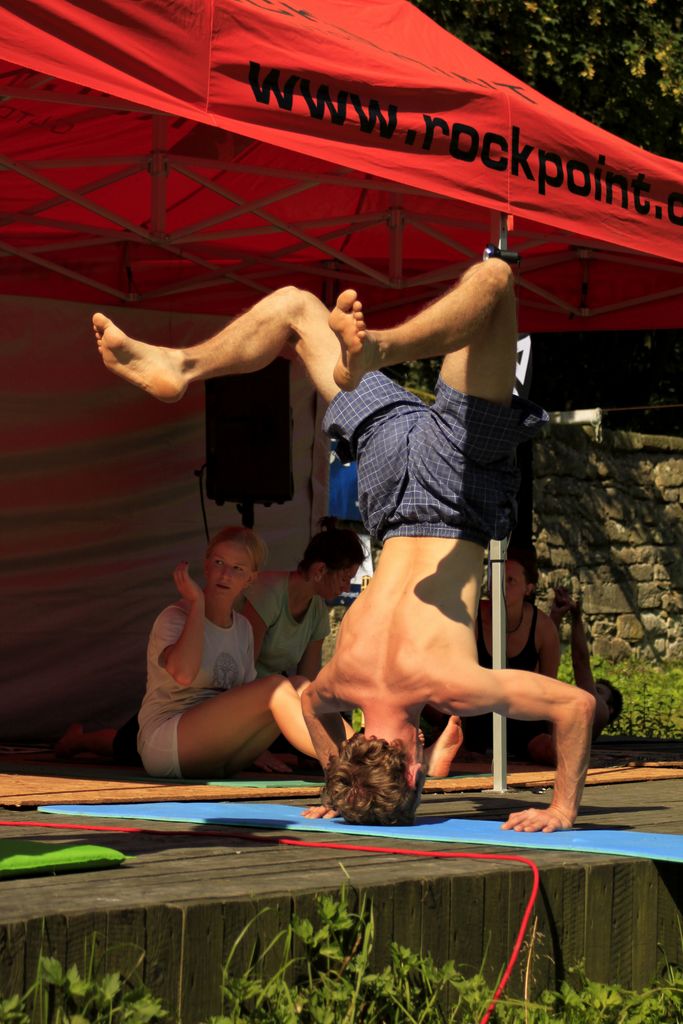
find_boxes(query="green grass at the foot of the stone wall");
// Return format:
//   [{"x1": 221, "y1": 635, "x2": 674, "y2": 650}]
[{"x1": 559, "y1": 652, "x2": 683, "y2": 739}]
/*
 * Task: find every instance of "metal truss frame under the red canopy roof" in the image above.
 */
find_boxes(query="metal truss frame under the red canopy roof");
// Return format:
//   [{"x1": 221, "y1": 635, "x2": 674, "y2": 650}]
[{"x1": 0, "y1": 71, "x2": 683, "y2": 321}]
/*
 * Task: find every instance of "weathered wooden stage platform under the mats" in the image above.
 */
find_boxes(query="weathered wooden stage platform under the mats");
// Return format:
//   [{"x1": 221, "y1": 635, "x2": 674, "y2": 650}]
[{"x1": 0, "y1": 744, "x2": 683, "y2": 1024}]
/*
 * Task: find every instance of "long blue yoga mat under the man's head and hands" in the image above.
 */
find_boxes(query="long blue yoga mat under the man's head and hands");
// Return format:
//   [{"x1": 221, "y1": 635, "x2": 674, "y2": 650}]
[{"x1": 38, "y1": 801, "x2": 683, "y2": 862}]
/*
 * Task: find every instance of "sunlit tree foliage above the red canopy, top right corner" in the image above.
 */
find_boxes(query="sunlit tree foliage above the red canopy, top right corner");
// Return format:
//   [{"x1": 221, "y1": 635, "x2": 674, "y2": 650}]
[{"x1": 414, "y1": 0, "x2": 683, "y2": 160}]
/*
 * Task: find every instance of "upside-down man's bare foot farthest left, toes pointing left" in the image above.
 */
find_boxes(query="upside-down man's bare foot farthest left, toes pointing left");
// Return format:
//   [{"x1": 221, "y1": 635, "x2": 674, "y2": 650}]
[{"x1": 92, "y1": 313, "x2": 187, "y2": 401}]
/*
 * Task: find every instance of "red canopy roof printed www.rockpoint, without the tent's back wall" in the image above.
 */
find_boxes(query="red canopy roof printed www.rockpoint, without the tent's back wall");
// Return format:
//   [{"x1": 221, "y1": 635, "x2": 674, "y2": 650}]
[{"x1": 0, "y1": 0, "x2": 683, "y2": 331}]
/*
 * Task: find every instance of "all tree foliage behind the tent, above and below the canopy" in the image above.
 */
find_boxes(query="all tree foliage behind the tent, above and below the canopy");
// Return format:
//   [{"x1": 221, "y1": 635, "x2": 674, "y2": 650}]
[{"x1": 392, "y1": 0, "x2": 683, "y2": 434}]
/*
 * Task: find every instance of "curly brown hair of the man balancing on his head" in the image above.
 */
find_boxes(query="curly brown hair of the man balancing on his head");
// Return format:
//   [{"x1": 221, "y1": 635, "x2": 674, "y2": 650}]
[{"x1": 322, "y1": 733, "x2": 425, "y2": 825}]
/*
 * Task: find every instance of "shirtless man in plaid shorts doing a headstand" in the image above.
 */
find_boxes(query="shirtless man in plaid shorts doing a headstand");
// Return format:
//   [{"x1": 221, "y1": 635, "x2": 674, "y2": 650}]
[{"x1": 93, "y1": 259, "x2": 595, "y2": 831}]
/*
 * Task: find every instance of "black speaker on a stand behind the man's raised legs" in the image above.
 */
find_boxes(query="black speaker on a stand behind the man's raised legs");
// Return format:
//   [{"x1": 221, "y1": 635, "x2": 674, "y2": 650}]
[{"x1": 205, "y1": 357, "x2": 294, "y2": 506}]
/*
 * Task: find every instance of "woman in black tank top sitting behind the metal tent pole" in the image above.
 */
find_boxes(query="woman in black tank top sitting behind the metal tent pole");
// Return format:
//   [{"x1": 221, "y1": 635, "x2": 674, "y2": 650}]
[{"x1": 462, "y1": 548, "x2": 560, "y2": 760}]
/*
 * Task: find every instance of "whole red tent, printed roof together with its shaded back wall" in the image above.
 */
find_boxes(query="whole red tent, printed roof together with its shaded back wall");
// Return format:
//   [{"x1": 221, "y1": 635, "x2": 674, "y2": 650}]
[{"x1": 0, "y1": 0, "x2": 683, "y2": 738}]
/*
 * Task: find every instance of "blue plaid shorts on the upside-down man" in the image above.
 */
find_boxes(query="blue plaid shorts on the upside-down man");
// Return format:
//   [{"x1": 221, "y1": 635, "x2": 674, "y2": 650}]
[{"x1": 323, "y1": 373, "x2": 548, "y2": 547}]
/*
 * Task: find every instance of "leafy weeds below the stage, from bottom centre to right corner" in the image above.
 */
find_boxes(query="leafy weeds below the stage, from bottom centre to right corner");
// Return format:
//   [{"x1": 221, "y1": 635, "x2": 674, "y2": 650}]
[{"x1": 210, "y1": 891, "x2": 683, "y2": 1024}]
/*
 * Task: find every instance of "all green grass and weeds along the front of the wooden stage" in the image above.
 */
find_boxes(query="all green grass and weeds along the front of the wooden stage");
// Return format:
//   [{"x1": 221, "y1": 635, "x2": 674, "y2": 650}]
[{"x1": 0, "y1": 891, "x2": 683, "y2": 1024}]
